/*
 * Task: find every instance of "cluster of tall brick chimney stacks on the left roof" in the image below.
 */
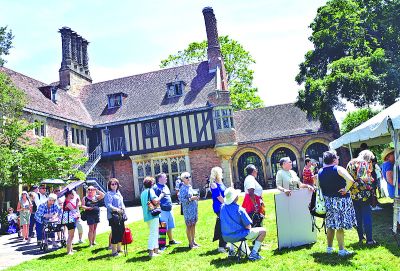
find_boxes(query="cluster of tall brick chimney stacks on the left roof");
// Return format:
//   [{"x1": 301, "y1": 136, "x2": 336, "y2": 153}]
[{"x1": 59, "y1": 27, "x2": 92, "y2": 96}]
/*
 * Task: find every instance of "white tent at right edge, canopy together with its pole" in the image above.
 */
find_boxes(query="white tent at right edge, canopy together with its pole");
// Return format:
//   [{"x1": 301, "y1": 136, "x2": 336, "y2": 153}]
[{"x1": 329, "y1": 101, "x2": 400, "y2": 232}]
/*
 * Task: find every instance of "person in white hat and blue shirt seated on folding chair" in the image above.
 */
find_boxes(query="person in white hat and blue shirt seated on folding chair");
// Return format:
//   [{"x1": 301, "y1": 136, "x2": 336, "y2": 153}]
[{"x1": 220, "y1": 187, "x2": 266, "y2": 261}]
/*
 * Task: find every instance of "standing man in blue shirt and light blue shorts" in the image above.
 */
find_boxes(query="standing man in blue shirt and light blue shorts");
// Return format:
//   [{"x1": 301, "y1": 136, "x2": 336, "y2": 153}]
[{"x1": 153, "y1": 172, "x2": 180, "y2": 248}]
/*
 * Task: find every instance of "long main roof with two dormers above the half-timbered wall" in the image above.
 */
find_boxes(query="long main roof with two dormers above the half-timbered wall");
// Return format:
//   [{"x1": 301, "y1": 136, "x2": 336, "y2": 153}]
[{"x1": 80, "y1": 61, "x2": 215, "y2": 125}]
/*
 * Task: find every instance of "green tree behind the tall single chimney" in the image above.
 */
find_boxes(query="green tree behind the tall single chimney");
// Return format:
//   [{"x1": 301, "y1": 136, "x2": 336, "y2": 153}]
[{"x1": 160, "y1": 36, "x2": 263, "y2": 110}]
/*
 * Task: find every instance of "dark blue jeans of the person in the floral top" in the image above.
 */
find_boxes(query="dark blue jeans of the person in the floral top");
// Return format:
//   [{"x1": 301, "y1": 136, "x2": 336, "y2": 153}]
[{"x1": 353, "y1": 200, "x2": 373, "y2": 242}]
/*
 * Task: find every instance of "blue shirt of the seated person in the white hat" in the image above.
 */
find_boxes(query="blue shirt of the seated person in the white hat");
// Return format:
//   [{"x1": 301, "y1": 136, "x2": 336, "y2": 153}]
[{"x1": 219, "y1": 202, "x2": 252, "y2": 242}]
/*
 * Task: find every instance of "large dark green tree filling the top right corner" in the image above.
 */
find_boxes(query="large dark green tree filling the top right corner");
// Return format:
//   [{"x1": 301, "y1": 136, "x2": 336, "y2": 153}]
[{"x1": 296, "y1": 0, "x2": 400, "y2": 125}]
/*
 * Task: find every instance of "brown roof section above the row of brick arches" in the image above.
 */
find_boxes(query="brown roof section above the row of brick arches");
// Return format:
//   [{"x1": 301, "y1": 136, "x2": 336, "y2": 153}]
[{"x1": 234, "y1": 103, "x2": 322, "y2": 143}]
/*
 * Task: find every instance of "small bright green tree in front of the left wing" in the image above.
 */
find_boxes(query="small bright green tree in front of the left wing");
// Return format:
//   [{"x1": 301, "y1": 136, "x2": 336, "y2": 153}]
[{"x1": 20, "y1": 138, "x2": 87, "y2": 184}]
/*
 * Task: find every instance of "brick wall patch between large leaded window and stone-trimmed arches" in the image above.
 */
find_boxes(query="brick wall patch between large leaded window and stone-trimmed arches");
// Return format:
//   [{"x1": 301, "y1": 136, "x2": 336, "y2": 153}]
[{"x1": 189, "y1": 148, "x2": 221, "y2": 188}]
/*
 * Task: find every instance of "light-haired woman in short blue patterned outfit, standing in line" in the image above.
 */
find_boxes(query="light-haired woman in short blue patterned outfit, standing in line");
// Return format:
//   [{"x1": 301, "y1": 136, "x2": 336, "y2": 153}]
[{"x1": 179, "y1": 172, "x2": 200, "y2": 248}]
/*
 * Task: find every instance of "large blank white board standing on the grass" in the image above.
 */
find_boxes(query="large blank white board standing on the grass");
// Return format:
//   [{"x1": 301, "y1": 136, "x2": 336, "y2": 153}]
[{"x1": 275, "y1": 189, "x2": 317, "y2": 249}]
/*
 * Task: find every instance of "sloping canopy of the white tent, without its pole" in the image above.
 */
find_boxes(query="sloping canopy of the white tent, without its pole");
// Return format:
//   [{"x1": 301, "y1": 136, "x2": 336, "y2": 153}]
[{"x1": 329, "y1": 101, "x2": 400, "y2": 149}]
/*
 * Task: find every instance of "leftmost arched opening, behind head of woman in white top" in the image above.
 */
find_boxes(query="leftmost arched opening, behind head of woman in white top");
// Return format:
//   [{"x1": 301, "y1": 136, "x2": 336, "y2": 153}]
[{"x1": 234, "y1": 152, "x2": 265, "y2": 190}]
